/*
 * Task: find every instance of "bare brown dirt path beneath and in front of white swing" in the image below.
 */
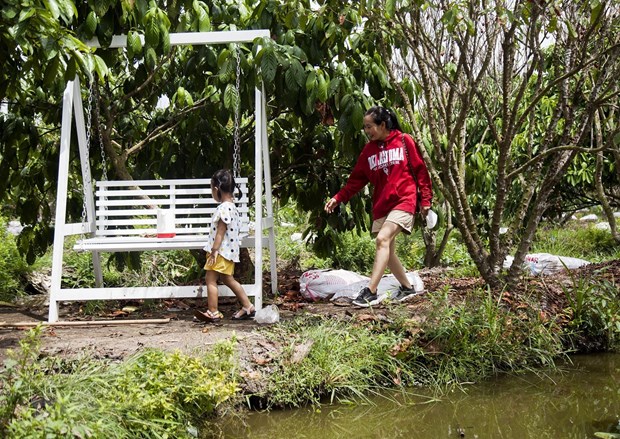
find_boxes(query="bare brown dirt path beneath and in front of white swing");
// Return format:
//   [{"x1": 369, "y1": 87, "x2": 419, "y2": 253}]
[{"x1": 0, "y1": 296, "x2": 359, "y2": 361}]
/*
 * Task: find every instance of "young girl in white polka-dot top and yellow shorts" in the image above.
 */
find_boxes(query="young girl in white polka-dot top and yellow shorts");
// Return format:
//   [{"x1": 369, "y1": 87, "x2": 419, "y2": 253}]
[{"x1": 194, "y1": 169, "x2": 255, "y2": 323}]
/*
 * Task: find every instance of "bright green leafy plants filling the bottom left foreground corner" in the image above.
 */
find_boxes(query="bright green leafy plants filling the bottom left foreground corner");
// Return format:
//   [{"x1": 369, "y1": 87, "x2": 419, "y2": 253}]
[{"x1": 0, "y1": 328, "x2": 237, "y2": 438}]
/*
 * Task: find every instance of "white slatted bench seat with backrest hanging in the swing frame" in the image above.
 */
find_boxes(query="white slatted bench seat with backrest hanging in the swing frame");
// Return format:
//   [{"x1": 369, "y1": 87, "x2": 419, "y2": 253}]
[{"x1": 73, "y1": 178, "x2": 272, "y2": 252}]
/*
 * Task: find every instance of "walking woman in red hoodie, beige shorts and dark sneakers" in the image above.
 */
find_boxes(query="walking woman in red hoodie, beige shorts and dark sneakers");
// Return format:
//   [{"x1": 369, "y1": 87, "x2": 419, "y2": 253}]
[{"x1": 325, "y1": 107, "x2": 433, "y2": 307}]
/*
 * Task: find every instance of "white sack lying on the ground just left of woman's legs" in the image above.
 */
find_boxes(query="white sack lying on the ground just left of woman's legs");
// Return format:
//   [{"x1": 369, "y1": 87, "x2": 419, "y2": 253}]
[{"x1": 299, "y1": 270, "x2": 368, "y2": 300}]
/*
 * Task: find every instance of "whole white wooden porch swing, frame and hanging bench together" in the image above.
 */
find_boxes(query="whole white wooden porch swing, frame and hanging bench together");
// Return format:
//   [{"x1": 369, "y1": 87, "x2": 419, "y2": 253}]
[{"x1": 48, "y1": 30, "x2": 277, "y2": 322}]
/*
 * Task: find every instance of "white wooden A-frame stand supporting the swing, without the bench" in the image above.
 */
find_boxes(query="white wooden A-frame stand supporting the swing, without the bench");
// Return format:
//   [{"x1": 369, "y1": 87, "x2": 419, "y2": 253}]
[{"x1": 48, "y1": 30, "x2": 277, "y2": 322}]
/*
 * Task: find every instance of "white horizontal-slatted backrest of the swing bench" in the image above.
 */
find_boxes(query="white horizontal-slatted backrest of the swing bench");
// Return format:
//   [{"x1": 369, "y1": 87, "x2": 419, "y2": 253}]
[{"x1": 95, "y1": 178, "x2": 250, "y2": 238}]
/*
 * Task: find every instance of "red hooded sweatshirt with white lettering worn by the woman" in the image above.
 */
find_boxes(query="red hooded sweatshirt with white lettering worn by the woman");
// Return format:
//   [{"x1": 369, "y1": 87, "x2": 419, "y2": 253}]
[{"x1": 334, "y1": 129, "x2": 433, "y2": 220}]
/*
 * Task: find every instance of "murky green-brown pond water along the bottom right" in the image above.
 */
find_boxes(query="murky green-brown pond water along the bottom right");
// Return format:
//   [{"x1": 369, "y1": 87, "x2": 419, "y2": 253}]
[{"x1": 212, "y1": 354, "x2": 620, "y2": 439}]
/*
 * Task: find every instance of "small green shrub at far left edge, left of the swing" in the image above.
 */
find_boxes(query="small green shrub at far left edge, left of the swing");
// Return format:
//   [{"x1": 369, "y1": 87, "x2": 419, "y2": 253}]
[{"x1": 0, "y1": 217, "x2": 29, "y2": 301}]
